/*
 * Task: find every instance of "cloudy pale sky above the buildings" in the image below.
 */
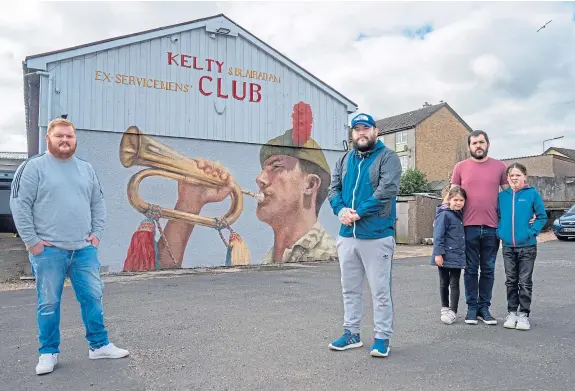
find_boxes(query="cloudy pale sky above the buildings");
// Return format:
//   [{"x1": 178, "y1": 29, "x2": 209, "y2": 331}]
[{"x1": 0, "y1": 1, "x2": 575, "y2": 158}]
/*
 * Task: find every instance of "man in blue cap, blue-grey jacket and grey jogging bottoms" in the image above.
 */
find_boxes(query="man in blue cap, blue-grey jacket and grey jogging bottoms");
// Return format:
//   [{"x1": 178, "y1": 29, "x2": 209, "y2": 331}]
[{"x1": 328, "y1": 114, "x2": 401, "y2": 357}]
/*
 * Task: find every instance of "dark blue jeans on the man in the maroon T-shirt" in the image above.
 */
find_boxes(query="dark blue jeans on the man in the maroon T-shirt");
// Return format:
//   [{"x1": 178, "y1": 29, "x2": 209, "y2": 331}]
[{"x1": 463, "y1": 225, "x2": 499, "y2": 311}]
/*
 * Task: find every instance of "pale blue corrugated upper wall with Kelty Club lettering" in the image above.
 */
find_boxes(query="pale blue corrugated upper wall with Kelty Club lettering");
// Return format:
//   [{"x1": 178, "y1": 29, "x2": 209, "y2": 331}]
[{"x1": 42, "y1": 28, "x2": 348, "y2": 150}]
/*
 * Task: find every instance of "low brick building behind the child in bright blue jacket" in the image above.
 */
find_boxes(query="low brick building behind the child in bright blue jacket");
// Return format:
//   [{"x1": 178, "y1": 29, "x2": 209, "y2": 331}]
[{"x1": 501, "y1": 147, "x2": 575, "y2": 178}]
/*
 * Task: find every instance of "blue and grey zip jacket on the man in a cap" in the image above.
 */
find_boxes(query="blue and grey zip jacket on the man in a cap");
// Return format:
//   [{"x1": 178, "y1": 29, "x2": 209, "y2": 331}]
[{"x1": 328, "y1": 140, "x2": 401, "y2": 239}]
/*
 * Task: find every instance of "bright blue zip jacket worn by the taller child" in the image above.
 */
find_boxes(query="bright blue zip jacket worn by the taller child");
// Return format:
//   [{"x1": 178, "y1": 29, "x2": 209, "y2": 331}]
[{"x1": 497, "y1": 185, "x2": 547, "y2": 247}]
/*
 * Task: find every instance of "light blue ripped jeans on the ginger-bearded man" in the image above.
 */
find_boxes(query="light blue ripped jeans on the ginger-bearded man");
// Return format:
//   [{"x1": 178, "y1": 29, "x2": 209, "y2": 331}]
[{"x1": 30, "y1": 245, "x2": 108, "y2": 354}]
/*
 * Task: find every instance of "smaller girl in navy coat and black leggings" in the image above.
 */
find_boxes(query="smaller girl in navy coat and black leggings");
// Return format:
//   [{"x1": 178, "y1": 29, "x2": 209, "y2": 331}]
[{"x1": 430, "y1": 186, "x2": 467, "y2": 324}]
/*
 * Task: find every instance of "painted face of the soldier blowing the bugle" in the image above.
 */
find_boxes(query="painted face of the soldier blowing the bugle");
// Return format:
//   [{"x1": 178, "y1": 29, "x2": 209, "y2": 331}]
[{"x1": 256, "y1": 155, "x2": 321, "y2": 226}]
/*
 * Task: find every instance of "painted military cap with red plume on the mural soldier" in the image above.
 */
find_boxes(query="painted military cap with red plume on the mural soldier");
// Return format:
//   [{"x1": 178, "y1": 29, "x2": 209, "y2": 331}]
[{"x1": 260, "y1": 102, "x2": 331, "y2": 174}]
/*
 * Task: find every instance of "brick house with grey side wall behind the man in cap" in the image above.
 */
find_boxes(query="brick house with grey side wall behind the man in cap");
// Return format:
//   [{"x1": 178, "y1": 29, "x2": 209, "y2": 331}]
[{"x1": 349, "y1": 102, "x2": 472, "y2": 184}]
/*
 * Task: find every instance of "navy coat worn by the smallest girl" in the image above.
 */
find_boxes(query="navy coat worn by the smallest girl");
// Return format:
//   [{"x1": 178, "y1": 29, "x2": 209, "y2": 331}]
[{"x1": 430, "y1": 204, "x2": 466, "y2": 269}]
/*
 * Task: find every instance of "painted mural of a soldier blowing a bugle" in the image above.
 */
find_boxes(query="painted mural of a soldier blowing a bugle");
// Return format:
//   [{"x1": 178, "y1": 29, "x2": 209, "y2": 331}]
[{"x1": 120, "y1": 102, "x2": 337, "y2": 271}]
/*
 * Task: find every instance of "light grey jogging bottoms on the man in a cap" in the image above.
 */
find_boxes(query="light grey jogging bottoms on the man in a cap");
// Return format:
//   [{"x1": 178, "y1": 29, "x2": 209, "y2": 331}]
[{"x1": 336, "y1": 236, "x2": 396, "y2": 339}]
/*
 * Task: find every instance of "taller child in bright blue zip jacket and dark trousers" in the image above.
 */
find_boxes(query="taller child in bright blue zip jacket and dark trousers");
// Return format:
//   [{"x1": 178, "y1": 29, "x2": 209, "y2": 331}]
[{"x1": 497, "y1": 163, "x2": 547, "y2": 330}]
